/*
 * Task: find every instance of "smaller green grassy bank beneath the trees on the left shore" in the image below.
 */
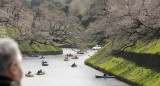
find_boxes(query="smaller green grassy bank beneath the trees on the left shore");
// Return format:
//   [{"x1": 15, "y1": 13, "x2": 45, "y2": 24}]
[{"x1": 1, "y1": 27, "x2": 62, "y2": 53}]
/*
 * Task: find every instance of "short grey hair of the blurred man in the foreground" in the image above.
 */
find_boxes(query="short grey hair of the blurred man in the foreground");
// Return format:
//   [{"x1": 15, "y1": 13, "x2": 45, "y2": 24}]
[{"x1": 0, "y1": 38, "x2": 21, "y2": 75}]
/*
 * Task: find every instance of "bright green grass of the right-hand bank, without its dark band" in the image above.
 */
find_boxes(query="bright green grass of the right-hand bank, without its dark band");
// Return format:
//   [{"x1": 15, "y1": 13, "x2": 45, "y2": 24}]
[{"x1": 86, "y1": 40, "x2": 160, "y2": 86}]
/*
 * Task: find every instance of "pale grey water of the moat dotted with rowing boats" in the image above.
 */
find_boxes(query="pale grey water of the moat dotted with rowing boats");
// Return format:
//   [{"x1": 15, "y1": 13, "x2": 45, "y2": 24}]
[{"x1": 22, "y1": 49, "x2": 129, "y2": 86}]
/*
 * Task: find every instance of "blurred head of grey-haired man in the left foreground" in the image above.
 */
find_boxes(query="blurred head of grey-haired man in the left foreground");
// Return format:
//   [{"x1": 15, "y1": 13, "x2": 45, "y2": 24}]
[{"x1": 0, "y1": 38, "x2": 22, "y2": 86}]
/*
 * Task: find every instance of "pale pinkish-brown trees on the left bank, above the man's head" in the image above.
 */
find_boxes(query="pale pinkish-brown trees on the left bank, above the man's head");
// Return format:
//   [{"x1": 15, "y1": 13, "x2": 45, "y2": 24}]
[{"x1": 0, "y1": 0, "x2": 82, "y2": 44}]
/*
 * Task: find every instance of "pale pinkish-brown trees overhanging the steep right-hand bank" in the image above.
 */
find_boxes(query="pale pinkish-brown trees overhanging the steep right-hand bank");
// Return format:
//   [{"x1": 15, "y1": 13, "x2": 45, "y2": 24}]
[{"x1": 85, "y1": 0, "x2": 160, "y2": 50}]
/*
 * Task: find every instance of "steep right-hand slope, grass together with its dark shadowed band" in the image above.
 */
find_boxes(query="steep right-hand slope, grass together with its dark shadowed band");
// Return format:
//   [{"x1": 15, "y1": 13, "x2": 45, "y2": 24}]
[{"x1": 85, "y1": 40, "x2": 160, "y2": 86}]
